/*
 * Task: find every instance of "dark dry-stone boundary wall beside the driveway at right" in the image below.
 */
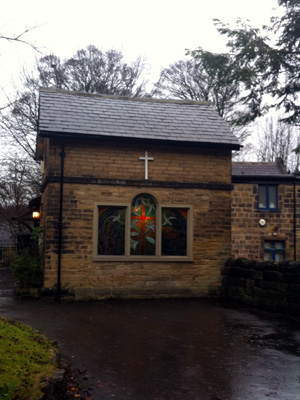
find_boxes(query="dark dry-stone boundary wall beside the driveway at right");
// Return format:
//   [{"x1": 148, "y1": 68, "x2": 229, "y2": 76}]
[{"x1": 222, "y1": 258, "x2": 300, "y2": 316}]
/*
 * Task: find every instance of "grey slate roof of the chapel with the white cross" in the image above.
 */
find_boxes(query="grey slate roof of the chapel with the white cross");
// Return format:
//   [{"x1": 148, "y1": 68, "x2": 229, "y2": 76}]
[{"x1": 39, "y1": 88, "x2": 240, "y2": 149}]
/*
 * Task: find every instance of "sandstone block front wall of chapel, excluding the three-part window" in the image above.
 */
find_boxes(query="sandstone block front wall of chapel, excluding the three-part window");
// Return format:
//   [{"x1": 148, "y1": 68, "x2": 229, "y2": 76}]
[{"x1": 42, "y1": 142, "x2": 231, "y2": 299}]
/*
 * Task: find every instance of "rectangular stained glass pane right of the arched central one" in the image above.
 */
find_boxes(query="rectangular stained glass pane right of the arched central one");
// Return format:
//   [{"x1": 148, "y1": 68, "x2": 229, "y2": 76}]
[{"x1": 161, "y1": 208, "x2": 187, "y2": 256}]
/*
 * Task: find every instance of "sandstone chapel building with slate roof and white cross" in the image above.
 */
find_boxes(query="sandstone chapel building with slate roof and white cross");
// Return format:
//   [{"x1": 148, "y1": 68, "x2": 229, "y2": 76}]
[{"x1": 37, "y1": 89, "x2": 240, "y2": 299}]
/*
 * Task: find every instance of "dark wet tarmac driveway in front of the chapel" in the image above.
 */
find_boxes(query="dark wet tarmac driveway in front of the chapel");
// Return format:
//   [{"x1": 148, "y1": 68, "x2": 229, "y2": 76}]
[{"x1": 0, "y1": 298, "x2": 300, "y2": 400}]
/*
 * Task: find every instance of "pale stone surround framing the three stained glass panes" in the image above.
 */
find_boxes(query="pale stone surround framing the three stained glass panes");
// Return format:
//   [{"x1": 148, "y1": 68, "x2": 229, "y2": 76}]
[{"x1": 93, "y1": 191, "x2": 193, "y2": 262}]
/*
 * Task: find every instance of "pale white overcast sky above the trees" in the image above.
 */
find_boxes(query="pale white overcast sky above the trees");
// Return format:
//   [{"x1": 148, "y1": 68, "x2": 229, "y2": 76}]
[{"x1": 0, "y1": 0, "x2": 277, "y2": 90}]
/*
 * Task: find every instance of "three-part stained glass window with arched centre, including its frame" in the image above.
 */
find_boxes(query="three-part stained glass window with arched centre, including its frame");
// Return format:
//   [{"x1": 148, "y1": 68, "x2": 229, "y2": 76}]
[{"x1": 93, "y1": 193, "x2": 193, "y2": 261}]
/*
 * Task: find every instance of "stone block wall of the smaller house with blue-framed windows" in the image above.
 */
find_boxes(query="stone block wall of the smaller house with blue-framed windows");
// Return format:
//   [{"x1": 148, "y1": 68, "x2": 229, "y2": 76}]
[{"x1": 232, "y1": 183, "x2": 300, "y2": 260}]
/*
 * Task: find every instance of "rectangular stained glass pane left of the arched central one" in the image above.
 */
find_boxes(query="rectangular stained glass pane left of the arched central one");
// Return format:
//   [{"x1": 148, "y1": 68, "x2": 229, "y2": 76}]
[{"x1": 98, "y1": 206, "x2": 126, "y2": 256}]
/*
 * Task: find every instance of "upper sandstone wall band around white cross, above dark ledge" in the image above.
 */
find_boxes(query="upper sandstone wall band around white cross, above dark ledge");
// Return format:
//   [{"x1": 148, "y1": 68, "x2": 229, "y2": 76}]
[{"x1": 45, "y1": 139, "x2": 231, "y2": 184}]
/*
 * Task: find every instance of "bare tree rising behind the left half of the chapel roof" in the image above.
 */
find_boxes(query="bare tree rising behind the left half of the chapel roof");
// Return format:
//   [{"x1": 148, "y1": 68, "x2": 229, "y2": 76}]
[{"x1": 32, "y1": 46, "x2": 146, "y2": 97}]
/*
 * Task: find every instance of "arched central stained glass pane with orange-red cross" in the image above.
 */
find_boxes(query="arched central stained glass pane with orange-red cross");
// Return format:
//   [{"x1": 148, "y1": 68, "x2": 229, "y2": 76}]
[{"x1": 130, "y1": 193, "x2": 156, "y2": 256}]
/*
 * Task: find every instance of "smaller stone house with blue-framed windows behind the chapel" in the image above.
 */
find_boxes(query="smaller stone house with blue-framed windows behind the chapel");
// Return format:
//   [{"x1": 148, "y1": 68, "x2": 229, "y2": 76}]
[{"x1": 231, "y1": 159, "x2": 300, "y2": 261}]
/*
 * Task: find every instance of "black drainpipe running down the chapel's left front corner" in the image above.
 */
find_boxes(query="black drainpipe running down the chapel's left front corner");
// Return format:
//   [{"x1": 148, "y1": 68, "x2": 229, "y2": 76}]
[{"x1": 55, "y1": 144, "x2": 66, "y2": 303}]
